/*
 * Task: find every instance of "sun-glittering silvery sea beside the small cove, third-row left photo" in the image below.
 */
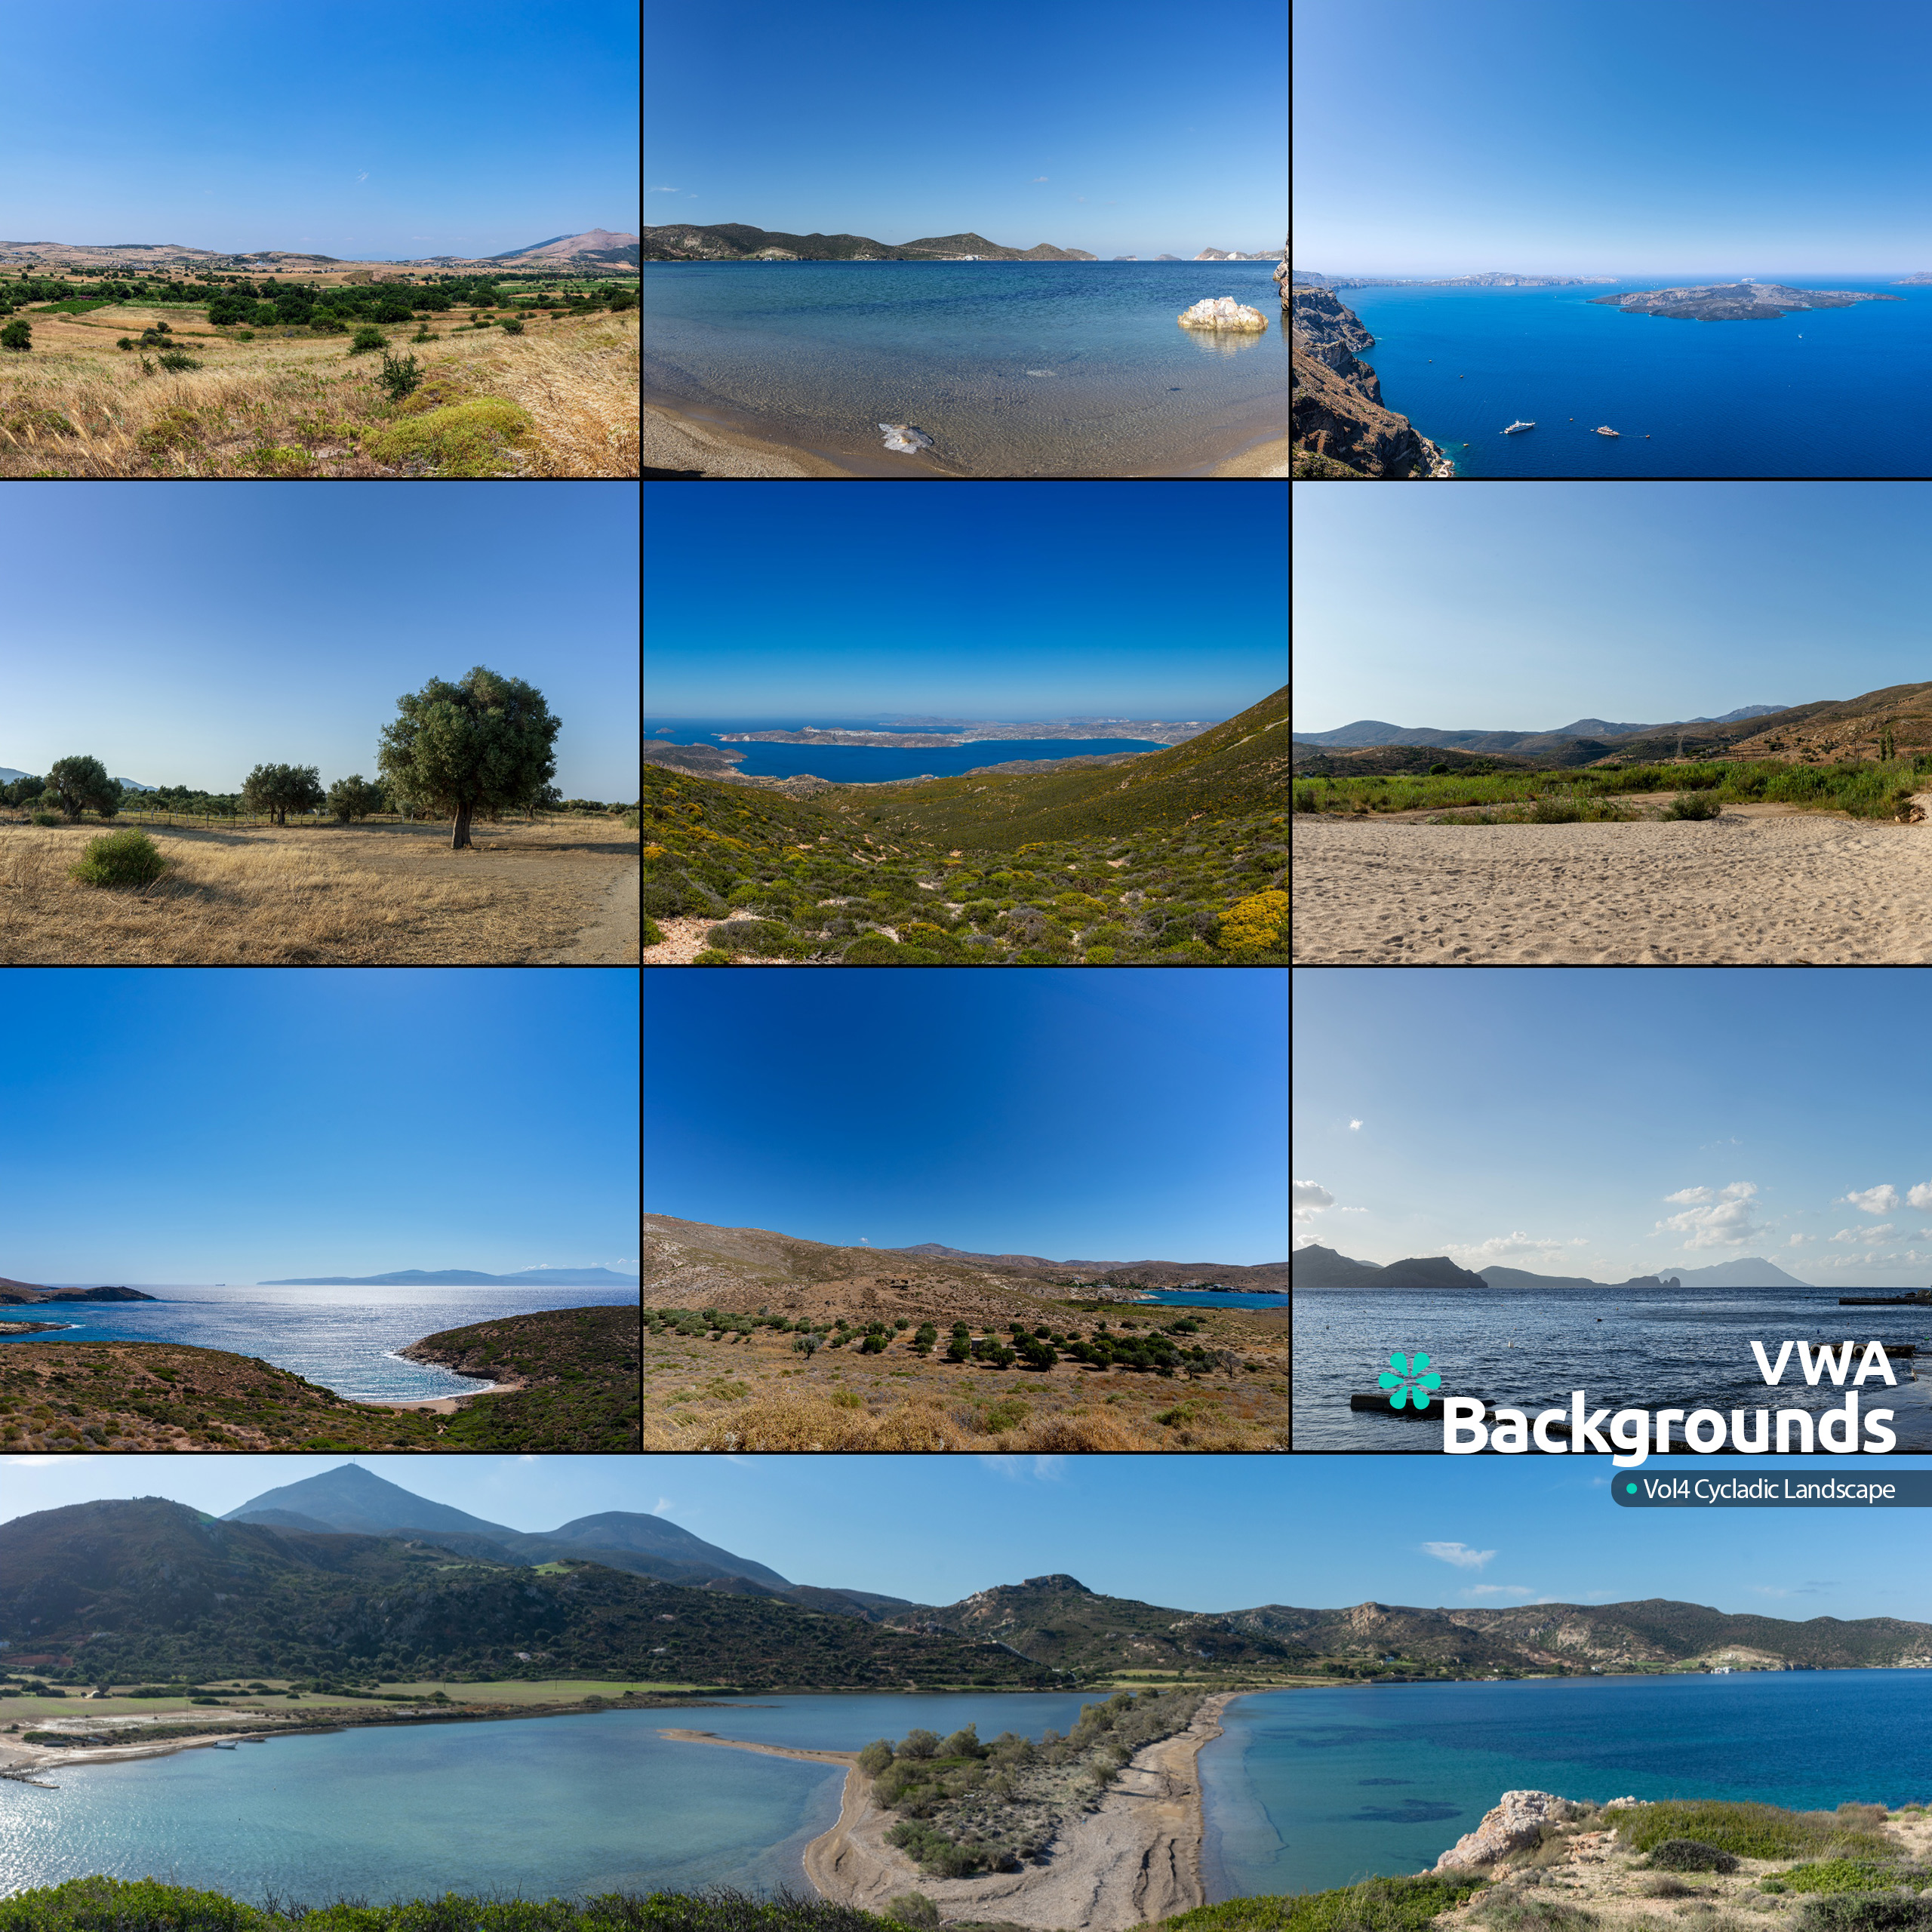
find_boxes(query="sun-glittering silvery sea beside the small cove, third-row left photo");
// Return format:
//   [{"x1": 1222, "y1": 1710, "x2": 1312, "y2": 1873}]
[{"x1": 0, "y1": 1281, "x2": 638, "y2": 1401}]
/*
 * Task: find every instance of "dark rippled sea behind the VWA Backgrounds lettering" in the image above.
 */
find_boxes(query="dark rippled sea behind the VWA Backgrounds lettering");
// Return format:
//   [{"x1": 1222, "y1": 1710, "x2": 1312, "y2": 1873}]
[{"x1": 1294, "y1": 1289, "x2": 1932, "y2": 1453}]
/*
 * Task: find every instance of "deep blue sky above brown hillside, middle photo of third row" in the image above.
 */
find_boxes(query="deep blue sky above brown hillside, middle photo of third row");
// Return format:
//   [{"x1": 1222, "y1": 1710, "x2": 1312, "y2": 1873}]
[{"x1": 643, "y1": 966, "x2": 1289, "y2": 1263}]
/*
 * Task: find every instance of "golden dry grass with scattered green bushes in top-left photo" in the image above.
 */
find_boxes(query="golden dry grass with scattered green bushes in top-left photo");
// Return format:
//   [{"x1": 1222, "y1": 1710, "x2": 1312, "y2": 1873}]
[{"x1": 0, "y1": 303, "x2": 639, "y2": 477}]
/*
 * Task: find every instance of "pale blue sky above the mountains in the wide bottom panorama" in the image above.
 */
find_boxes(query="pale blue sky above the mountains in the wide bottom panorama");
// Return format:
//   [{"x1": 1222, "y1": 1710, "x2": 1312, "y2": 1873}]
[{"x1": 11, "y1": 1455, "x2": 1932, "y2": 1619}]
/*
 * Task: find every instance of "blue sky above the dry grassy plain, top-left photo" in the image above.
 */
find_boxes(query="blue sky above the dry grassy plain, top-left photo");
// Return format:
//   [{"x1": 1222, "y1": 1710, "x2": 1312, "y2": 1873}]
[{"x1": 4, "y1": 0, "x2": 638, "y2": 261}]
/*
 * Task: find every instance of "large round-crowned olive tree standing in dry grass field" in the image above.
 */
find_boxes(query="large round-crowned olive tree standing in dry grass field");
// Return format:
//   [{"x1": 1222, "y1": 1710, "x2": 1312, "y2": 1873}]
[{"x1": 377, "y1": 665, "x2": 562, "y2": 852}]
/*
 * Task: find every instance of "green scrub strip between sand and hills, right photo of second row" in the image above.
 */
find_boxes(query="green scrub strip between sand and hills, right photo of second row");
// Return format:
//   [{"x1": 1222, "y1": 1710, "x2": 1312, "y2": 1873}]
[{"x1": 1294, "y1": 753, "x2": 1932, "y2": 825}]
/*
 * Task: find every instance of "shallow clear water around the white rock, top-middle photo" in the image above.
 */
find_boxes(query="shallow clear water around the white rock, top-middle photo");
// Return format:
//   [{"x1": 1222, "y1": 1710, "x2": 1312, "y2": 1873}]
[{"x1": 643, "y1": 261, "x2": 1291, "y2": 477}]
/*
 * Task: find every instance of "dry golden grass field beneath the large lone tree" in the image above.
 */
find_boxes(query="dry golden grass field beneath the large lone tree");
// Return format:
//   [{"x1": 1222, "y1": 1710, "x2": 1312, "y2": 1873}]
[{"x1": 0, "y1": 821, "x2": 638, "y2": 966}]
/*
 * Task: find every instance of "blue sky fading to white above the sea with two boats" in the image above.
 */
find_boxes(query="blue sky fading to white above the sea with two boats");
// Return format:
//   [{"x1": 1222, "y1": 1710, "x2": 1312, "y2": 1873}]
[{"x1": 1294, "y1": 0, "x2": 1932, "y2": 276}]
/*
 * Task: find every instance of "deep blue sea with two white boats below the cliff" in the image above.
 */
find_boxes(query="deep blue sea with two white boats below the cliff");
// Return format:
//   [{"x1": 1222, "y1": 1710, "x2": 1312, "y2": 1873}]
[{"x1": 1337, "y1": 272, "x2": 1932, "y2": 477}]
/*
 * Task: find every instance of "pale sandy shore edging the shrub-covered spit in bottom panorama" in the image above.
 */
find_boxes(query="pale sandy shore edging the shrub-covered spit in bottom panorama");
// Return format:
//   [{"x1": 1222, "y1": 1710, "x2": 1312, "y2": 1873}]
[{"x1": 663, "y1": 1693, "x2": 1232, "y2": 1932}]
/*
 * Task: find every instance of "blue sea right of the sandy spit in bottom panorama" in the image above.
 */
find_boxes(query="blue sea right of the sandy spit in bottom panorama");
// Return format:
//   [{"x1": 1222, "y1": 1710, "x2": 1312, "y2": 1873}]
[{"x1": 1200, "y1": 1671, "x2": 1932, "y2": 1903}]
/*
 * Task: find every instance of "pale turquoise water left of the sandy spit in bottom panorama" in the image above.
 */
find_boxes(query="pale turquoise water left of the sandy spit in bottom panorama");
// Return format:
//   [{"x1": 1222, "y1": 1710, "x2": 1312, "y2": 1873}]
[{"x1": 0, "y1": 1694, "x2": 1112, "y2": 1903}]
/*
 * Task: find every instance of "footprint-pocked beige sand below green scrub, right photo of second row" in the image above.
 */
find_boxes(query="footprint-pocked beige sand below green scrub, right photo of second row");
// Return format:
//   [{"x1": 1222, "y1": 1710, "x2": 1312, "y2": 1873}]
[{"x1": 1291, "y1": 806, "x2": 1932, "y2": 966}]
